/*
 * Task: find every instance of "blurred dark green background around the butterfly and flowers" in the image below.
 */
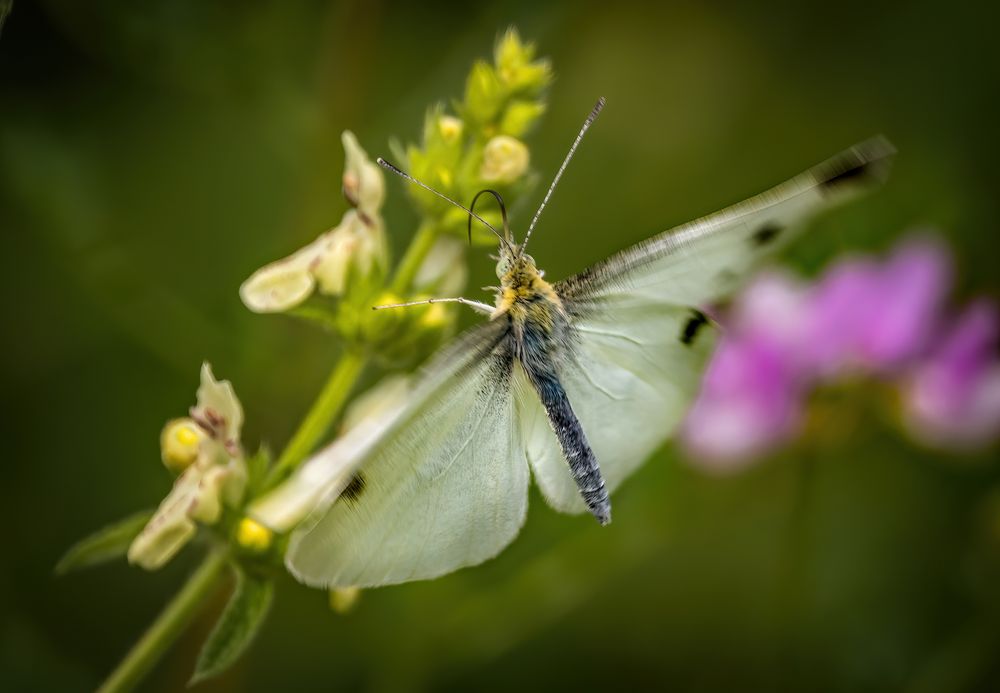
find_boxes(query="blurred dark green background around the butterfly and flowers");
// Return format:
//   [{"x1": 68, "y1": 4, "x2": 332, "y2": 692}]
[{"x1": 0, "y1": 0, "x2": 1000, "y2": 691}]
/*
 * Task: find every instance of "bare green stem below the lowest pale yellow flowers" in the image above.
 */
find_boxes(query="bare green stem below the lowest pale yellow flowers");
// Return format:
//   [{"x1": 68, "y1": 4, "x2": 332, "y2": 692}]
[{"x1": 98, "y1": 550, "x2": 226, "y2": 693}]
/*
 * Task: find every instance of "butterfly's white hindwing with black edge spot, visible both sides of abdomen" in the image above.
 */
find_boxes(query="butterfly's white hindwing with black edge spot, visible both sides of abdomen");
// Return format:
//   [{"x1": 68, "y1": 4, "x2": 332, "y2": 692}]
[{"x1": 518, "y1": 296, "x2": 715, "y2": 512}]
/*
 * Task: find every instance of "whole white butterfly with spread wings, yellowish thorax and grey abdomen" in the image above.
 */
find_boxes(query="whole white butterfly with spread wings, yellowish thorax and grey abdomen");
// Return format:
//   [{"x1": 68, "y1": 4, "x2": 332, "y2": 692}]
[{"x1": 272, "y1": 99, "x2": 894, "y2": 587}]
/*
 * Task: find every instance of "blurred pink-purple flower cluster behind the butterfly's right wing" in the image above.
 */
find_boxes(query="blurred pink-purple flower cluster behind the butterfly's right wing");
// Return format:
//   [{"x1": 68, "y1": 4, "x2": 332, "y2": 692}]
[{"x1": 681, "y1": 238, "x2": 1000, "y2": 470}]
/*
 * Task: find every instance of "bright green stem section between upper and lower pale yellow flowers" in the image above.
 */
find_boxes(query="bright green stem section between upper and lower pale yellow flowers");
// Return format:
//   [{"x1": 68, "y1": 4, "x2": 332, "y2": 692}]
[{"x1": 264, "y1": 350, "x2": 367, "y2": 488}]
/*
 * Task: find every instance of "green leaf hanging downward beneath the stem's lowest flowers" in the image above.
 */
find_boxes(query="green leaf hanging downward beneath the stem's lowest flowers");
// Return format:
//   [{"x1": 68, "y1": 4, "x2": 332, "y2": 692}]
[{"x1": 188, "y1": 568, "x2": 274, "y2": 685}]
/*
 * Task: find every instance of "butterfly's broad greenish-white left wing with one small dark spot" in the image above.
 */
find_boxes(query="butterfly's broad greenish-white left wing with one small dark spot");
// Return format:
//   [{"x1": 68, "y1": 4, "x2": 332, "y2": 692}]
[{"x1": 286, "y1": 323, "x2": 528, "y2": 587}]
